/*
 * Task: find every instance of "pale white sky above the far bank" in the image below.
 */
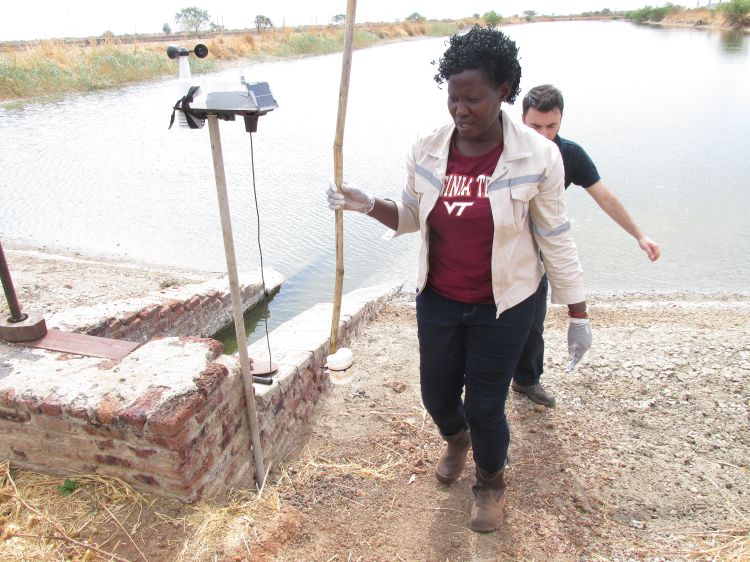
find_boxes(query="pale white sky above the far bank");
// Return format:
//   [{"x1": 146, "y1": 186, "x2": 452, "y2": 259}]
[{"x1": 0, "y1": 0, "x2": 706, "y2": 41}]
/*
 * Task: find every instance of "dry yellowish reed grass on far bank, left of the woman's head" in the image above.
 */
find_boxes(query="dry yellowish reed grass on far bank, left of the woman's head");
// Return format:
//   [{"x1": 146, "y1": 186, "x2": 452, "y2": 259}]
[{"x1": 0, "y1": 21, "x2": 461, "y2": 100}]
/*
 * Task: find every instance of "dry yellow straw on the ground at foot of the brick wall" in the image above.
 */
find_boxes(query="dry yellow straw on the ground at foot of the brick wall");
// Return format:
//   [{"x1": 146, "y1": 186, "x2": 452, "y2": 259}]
[{"x1": 0, "y1": 430, "x2": 405, "y2": 562}]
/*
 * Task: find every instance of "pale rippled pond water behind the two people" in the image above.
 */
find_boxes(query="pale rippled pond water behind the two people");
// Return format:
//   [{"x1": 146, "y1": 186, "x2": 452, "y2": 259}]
[{"x1": 0, "y1": 22, "x2": 750, "y2": 346}]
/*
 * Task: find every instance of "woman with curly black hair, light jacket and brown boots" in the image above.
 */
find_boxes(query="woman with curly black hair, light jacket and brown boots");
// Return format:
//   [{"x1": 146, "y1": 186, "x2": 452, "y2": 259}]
[{"x1": 328, "y1": 26, "x2": 591, "y2": 532}]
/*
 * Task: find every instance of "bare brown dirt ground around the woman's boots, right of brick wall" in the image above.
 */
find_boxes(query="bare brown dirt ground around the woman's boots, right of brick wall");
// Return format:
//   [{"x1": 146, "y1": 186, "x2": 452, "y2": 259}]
[{"x1": 244, "y1": 290, "x2": 750, "y2": 560}]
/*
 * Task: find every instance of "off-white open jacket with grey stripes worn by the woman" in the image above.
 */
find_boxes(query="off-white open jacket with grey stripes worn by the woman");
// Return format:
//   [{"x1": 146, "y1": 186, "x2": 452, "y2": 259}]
[{"x1": 395, "y1": 107, "x2": 584, "y2": 316}]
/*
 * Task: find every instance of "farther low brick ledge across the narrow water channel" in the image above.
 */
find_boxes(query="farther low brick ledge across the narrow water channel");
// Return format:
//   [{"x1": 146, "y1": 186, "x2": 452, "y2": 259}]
[{"x1": 47, "y1": 267, "x2": 284, "y2": 342}]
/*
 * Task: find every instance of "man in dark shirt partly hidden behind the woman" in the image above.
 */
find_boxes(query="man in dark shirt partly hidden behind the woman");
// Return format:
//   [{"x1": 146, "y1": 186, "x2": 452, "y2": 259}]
[{"x1": 512, "y1": 84, "x2": 660, "y2": 407}]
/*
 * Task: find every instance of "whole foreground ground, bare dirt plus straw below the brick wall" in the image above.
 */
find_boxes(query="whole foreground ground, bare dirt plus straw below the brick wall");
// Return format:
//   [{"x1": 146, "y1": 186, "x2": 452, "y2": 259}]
[{"x1": 0, "y1": 250, "x2": 750, "y2": 562}]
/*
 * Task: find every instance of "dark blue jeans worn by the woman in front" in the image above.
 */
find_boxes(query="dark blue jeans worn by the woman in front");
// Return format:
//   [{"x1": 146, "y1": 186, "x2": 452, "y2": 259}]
[{"x1": 417, "y1": 287, "x2": 534, "y2": 472}]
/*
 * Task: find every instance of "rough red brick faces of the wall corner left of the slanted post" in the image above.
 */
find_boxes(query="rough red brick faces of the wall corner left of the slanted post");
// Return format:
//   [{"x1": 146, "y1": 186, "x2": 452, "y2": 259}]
[{"x1": 0, "y1": 338, "x2": 251, "y2": 501}]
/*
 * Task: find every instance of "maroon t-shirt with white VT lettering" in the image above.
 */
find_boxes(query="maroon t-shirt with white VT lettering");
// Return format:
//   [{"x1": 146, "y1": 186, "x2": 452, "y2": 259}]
[{"x1": 427, "y1": 137, "x2": 503, "y2": 304}]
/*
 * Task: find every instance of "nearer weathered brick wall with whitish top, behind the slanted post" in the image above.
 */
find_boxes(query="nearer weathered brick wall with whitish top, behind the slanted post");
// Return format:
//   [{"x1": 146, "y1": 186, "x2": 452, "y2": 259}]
[{"x1": 0, "y1": 280, "x2": 406, "y2": 501}]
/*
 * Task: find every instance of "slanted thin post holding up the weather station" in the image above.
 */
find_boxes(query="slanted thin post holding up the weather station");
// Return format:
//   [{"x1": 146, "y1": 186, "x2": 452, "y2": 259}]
[{"x1": 208, "y1": 115, "x2": 266, "y2": 489}]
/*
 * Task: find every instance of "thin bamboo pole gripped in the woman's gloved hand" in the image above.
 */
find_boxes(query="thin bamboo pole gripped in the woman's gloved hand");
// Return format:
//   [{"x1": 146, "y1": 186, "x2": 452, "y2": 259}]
[{"x1": 328, "y1": 0, "x2": 357, "y2": 353}]
